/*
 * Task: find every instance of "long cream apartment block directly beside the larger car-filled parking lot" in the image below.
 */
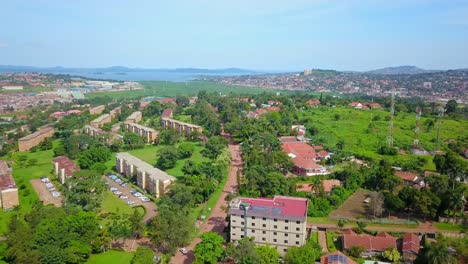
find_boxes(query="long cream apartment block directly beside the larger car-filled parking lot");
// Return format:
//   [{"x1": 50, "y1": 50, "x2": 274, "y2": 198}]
[{"x1": 116, "y1": 152, "x2": 175, "y2": 198}]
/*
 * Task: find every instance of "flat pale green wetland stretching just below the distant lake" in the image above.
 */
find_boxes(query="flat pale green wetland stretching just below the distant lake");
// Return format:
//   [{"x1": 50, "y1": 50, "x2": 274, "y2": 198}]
[{"x1": 86, "y1": 81, "x2": 274, "y2": 99}]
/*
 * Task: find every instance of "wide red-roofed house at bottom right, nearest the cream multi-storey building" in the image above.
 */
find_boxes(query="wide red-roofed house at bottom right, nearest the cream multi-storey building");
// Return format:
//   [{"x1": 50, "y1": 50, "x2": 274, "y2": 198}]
[{"x1": 342, "y1": 229, "x2": 397, "y2": 257}]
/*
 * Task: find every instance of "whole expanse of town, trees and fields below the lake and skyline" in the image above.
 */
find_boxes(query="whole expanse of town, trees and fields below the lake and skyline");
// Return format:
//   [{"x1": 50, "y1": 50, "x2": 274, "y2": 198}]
[{"x1": 0, "y1": 70, "x2": 468, "y2": 264}]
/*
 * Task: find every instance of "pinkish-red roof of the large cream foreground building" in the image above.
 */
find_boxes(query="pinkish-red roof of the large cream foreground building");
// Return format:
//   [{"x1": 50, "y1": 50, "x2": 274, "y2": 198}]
[{"x1": 240, "y1": 195, "x2": 308, "y2": 217}]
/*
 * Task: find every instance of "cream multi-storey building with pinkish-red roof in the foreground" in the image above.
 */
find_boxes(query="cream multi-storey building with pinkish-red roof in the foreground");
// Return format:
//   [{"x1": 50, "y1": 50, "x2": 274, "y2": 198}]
[{"x1": 229, "y1": 196, "x2": 308, "y2": 255}]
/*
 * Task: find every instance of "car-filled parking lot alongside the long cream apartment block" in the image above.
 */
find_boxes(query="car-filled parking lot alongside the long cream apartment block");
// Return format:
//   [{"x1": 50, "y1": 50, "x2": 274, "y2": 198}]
[{"x1": 103, "y1": 175, "x2": 157, "y2": 222}]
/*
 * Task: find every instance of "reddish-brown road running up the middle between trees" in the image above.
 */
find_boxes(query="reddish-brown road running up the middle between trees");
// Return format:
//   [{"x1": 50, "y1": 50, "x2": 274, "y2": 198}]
[{"x1": 170, "y1": 142, "x2": 242, "y2": 264}]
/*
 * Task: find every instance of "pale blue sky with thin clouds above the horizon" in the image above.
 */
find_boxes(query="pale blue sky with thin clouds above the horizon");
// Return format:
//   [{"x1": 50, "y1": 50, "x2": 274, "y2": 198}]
[{"x1": 0, "y1": 0, "x2": 468, "y2": 70}]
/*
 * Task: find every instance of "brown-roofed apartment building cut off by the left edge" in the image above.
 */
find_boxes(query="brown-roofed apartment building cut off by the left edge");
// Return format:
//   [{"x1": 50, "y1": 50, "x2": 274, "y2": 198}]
[{"x1": 0, "y1": 160, "x2": 19, "y2": 210}]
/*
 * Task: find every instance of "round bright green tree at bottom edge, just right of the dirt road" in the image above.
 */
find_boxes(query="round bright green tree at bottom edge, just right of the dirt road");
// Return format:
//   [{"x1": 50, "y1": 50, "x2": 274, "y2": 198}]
[{"x1": 194, "y1": 232, "x2": 225, "y2": 264}]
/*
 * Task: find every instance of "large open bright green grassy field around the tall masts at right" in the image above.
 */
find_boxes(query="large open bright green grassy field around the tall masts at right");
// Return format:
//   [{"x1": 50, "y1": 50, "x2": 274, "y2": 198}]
[{"x1": 299, "y1": 107, "x2": 468, "y2": 170}]
